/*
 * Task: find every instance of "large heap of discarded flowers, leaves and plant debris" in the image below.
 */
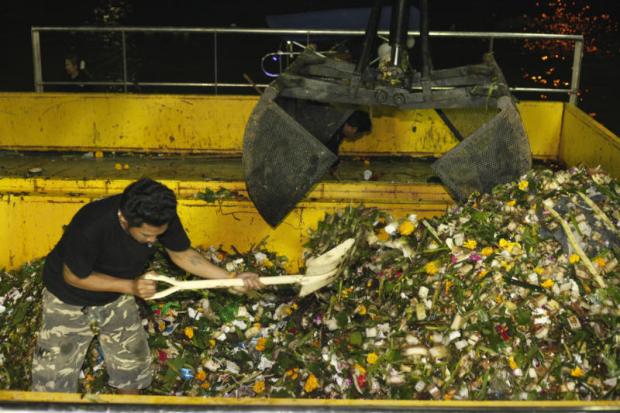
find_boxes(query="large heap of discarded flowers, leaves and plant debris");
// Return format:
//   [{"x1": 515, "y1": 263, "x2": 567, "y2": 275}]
[{"x1": 0, "y1": 168, "x2": 620, "y2": 400}]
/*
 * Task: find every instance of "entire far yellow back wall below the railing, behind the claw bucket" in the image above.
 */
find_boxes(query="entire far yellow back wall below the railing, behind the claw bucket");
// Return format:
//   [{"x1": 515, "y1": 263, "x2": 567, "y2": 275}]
[{"x1": 0, "y1": 93, "x2": 563, "y2": 159}]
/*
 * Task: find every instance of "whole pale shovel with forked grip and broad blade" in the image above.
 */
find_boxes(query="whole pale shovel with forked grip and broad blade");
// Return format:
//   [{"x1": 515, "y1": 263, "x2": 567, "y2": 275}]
[{"x1": 144, "y1": 238, "x2": 355, "y2": 300}]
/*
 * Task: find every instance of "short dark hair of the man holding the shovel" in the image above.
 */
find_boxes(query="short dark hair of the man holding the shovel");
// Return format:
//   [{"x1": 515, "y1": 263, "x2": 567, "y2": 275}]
[{"x1": 120, "y1": 178, "x2": 177, "y2": 227}]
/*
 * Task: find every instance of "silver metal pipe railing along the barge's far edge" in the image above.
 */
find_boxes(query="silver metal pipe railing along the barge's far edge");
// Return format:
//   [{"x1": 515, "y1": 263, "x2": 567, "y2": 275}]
[{"x1": 31, "y1": 27, "x2": 584, "y2": 105}]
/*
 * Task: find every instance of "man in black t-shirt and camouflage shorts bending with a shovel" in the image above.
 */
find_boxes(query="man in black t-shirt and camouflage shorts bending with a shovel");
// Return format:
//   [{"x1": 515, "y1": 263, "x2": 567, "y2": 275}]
[{"x1": 32, "y1": 178, "x2": 262, "y2": 394}]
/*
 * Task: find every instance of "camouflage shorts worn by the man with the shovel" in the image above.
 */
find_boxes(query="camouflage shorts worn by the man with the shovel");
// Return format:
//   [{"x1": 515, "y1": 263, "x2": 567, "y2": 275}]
[{"x1": 32, "y1": 289, "x2": 153, "y2": 392}]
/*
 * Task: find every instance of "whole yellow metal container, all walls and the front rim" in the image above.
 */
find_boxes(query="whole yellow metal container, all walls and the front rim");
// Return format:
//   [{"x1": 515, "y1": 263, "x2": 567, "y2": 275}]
[{"x1": 0, "y1": 93, "x2": 620, "y2": 410}]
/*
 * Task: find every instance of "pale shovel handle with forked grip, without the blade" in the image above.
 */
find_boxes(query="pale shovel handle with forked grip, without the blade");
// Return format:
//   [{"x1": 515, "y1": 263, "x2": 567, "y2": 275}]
[{"x1": 144, "y1": 274, "x2": 303, "y2": 300}]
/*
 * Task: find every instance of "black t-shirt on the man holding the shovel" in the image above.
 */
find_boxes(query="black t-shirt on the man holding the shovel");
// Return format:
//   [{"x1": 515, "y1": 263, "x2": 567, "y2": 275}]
[{"x1": 43, "y1": 195, "x2": 190, "y2": 306}]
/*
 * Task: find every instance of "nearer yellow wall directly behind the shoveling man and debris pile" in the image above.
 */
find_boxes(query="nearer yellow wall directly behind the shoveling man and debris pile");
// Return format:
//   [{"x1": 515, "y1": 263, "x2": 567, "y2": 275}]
[{"x1": 0, "y1": 178, "x2": 452, "y2": 271}]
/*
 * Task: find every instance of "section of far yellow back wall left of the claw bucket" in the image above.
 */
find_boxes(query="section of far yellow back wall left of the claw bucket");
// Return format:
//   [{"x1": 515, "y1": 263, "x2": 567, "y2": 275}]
[{"x1": 0, "y1": 93, "x2": 256, "y2": 153}]
